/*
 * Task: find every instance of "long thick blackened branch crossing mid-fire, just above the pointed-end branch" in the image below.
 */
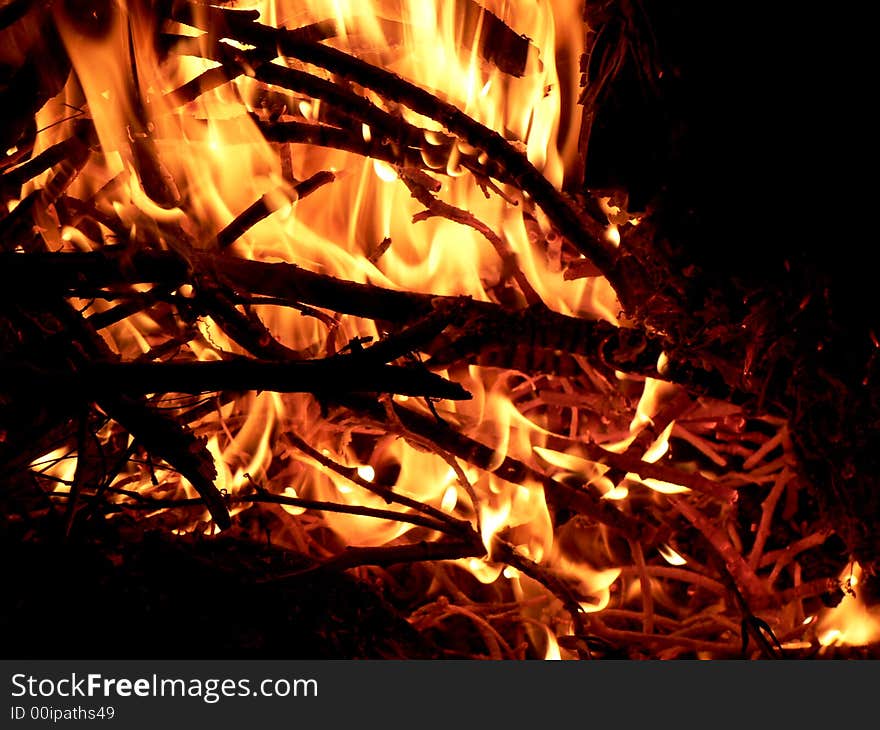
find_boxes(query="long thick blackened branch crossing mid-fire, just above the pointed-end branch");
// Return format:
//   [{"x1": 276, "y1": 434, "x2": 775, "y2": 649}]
[{"x1": 0, "y1": 248, "x2": 672, "y2": 383}]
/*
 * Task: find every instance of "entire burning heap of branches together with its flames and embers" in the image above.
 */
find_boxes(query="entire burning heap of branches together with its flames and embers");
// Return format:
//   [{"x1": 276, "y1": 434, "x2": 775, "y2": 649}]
[{"x1": 0, "y1": 0, "x2": 880, "y2": 658}]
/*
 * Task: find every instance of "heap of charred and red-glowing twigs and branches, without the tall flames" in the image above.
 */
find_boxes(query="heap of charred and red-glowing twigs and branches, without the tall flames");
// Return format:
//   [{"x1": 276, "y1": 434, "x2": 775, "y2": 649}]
[{"x1": 0, "y1": 2, "x2": 872, "y2": 658}]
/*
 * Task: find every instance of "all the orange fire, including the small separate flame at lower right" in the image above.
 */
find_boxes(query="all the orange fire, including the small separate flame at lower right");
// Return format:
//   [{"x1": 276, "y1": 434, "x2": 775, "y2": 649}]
[{"x1": 7, "y1": 0, "x2": 880, "y2": 659}]
